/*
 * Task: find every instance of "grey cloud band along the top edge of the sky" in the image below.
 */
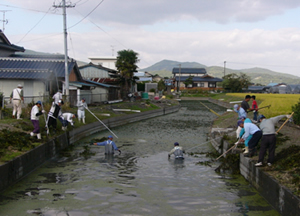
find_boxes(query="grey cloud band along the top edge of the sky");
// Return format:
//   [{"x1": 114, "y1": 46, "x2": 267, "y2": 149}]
[{"x1": 7, "y1": 0, "x2": 300, "y2": 26}]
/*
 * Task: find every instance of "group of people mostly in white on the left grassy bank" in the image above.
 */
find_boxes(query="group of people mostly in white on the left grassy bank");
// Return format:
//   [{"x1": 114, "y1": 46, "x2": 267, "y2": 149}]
[{"x1": 10, "y1": 84, "x2": 87, "y2": 139}]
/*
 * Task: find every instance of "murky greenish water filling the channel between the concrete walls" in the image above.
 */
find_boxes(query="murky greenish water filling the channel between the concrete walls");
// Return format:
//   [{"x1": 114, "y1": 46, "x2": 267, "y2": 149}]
[{"x1": 0, "y1": 101, "x2": 279, "y2": 216}]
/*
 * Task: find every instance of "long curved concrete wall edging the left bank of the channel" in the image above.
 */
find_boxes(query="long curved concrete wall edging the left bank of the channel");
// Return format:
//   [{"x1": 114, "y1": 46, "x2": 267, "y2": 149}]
[{"x1": 0, "y1": 105, "x2": 180, "y2": 191}]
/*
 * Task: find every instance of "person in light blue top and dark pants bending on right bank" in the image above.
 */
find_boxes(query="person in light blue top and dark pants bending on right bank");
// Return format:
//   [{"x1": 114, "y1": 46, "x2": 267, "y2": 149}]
[{"x1": 236, "y1": 120, "x2": 262, "y2": 157}]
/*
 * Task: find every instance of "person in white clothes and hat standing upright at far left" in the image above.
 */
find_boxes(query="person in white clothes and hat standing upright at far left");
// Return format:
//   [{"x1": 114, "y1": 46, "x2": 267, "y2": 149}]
[{"x1": 10, "y1": 84, "x2": 24, "y2": 119}]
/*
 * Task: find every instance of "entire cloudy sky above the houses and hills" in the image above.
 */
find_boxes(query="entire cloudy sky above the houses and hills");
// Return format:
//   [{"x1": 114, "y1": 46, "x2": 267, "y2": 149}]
[{"x1": 0, "y1": 0, "x2": 300, "y2": 76}]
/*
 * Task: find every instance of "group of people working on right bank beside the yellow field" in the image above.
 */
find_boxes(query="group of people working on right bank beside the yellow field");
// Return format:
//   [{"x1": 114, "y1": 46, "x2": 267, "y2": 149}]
[{"x1": 234, "y1": 95, "x2": 290, "y2": 166}]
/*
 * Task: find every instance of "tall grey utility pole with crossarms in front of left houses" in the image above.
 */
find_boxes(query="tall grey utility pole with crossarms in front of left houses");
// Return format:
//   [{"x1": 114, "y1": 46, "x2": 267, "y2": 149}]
[{"x1": 53, "y1": 0, "x2": 75, "y2": 101}]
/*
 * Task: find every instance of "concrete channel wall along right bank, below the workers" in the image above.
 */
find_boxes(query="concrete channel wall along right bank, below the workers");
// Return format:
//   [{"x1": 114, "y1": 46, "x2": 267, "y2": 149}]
[{"x1": 208, "y1": 98, "x2": 300, "y2": 216}]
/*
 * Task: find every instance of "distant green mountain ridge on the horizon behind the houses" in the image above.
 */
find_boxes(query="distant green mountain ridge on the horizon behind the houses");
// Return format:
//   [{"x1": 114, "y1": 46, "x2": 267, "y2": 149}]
[{"x1": 140, "y1": 60, "x2": 300, "y2": 85}]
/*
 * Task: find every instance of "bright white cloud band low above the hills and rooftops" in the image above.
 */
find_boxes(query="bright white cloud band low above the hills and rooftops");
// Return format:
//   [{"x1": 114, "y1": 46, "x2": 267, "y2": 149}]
[{"x1": 10, "y1": 28, "x2": 300, "y2": 75}]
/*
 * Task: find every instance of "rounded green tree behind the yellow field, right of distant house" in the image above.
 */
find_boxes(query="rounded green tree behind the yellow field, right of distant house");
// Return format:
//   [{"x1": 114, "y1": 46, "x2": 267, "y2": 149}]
[{"x1": 222, "y1": 73, "x2": 251, "y2": 92}]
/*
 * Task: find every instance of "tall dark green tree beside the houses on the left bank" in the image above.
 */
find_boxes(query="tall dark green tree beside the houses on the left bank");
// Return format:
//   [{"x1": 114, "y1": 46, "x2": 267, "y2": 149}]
[{"x1": 116, "y1": 50, "x2": 139, "y2": 96}]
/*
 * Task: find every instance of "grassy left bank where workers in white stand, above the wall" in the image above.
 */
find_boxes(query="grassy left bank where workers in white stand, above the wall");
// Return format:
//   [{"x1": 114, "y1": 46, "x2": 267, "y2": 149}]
[{"x1": 0, "y1": 100, "x2": 178, "y2": 164}]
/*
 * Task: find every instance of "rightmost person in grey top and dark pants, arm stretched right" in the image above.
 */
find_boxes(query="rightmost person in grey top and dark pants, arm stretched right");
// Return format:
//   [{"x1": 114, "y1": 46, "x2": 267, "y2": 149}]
[{"x1": 255, "y1": 115, "x2": 290, "y2": 166}]
